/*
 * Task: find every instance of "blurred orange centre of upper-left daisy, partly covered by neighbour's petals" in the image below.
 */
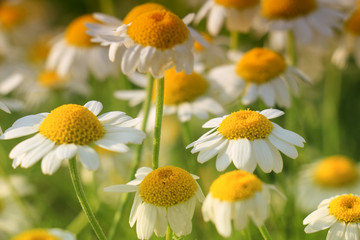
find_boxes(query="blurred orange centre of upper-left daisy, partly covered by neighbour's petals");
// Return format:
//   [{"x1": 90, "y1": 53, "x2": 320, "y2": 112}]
[{"x1": 65, "y1": 14, "x2": 100, "y2": 48}]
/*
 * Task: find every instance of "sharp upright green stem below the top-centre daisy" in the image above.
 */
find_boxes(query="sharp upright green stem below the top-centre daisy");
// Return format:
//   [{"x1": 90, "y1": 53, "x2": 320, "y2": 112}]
[{"x1": 152, "y1": 78, "x2": 164, "y2": 169}]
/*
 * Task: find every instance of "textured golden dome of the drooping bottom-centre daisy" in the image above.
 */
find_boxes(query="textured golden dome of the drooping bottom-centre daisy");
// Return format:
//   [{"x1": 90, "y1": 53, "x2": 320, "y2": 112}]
[{"x1": 139, "y1": 166, "x2": 197, "y2": 207}]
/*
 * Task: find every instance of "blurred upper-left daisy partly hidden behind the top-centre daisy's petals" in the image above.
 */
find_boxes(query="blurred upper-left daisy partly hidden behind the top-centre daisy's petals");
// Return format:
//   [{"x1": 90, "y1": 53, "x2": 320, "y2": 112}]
[{"x1": 46, "y1": 14, "x2": 118, "y2": 80}]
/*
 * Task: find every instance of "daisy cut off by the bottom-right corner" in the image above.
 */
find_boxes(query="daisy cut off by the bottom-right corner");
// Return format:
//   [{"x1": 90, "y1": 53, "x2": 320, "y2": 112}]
[{"x1": 303, "y1": 194, "x2": 360, "y2": 240}]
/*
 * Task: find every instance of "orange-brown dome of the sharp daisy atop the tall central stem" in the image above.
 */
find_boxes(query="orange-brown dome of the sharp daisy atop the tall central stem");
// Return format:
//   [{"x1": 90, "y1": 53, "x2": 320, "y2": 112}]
[{"x1": 127, "y1": 10, "x2": 189, "y2": 50}]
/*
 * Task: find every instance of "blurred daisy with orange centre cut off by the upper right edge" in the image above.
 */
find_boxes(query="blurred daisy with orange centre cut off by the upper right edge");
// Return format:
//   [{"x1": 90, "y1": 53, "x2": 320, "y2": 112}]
[{"x1": 331, "y1": 7, "x2": 360, "y2": 68}]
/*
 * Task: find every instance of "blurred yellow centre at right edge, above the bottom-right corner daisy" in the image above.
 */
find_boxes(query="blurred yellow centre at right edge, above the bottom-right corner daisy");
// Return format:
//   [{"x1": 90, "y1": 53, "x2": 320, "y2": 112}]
[{"x1": 314, "y1": 156, "x2": 359, "y2": 187}]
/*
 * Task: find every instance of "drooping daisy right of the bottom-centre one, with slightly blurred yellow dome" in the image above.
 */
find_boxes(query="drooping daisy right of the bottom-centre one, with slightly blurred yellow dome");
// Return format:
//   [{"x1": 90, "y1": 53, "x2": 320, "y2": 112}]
[{"x1": 201, "y1": 170, "x2": 274, "y2": 237}]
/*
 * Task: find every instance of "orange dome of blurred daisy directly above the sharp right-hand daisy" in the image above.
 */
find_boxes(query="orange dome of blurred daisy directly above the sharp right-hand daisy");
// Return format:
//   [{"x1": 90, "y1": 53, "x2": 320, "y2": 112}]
[{"x1": 236, "y1": 48, "x2": 286, "y2": 84}]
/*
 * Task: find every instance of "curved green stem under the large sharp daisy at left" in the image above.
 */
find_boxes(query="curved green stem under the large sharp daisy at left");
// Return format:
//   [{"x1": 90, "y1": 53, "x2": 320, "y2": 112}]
[{"x1": 69, "y1": 158, "x2": 106, "y2": 240}]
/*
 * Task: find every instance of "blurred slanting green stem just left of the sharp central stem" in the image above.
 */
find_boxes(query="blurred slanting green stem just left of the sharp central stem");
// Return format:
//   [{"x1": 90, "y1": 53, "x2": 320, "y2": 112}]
[{"x1": 108, "y1": 74, "x2": 154, "y2": 240}]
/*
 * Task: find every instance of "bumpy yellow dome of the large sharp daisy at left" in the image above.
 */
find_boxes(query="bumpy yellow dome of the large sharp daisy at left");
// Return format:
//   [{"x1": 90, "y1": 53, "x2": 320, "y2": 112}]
[{"x1": 39, "y1": 104, "x2": 105, "y2": 145}]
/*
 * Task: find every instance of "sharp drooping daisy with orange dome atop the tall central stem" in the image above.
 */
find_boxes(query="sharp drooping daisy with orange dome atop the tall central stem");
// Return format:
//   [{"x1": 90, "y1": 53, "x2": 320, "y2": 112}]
[{"x1": 93, "y1": 10, "x2": 206, "y2": 78}]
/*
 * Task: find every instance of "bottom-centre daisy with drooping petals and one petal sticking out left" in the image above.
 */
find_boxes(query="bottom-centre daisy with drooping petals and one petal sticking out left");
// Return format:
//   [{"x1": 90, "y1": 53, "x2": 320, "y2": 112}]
[{"x1": 105, "y1": 166, "x2": 204, "y2": 239}]
